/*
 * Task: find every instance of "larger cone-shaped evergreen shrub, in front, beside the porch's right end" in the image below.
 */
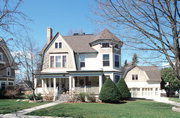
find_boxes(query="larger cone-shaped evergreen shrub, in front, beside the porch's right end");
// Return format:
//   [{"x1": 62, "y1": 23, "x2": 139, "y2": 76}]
[{"x1": 99, "y1": 78, "x2": 121, "y2": 103}]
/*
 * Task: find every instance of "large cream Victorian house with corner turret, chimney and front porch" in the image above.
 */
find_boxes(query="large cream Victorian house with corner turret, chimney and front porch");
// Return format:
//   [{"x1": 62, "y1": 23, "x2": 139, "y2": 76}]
[{"x1": 35, "y1": 28, "x2": 123, "y2": 98}]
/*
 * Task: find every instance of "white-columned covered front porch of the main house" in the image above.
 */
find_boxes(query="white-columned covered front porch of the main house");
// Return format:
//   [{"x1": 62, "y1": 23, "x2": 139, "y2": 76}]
[{"x1": 34, "y1": 73, "x2": 103, "y2": 99}]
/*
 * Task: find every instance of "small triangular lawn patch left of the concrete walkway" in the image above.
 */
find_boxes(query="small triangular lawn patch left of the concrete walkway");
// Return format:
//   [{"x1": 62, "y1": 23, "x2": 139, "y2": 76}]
[{"x1": 0, "y1": 99, "x2": 47, "y2": 114}]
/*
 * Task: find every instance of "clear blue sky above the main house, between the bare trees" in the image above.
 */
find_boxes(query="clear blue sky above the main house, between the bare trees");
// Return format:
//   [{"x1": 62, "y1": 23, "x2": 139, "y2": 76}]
[{"x1": 13, "y1": 0, "x2": 167, "y2": 65}]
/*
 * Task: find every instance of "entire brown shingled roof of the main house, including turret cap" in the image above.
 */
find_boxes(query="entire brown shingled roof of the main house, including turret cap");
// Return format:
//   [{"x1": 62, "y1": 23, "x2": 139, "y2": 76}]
[{"x1": 41, "y1": 29, "x2": 121, "y2": 53}]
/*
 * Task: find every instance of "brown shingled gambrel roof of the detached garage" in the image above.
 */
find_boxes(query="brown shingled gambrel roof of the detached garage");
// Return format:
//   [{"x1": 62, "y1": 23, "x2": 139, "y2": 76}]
[{"x1": 123, "y1": 65, "x2": 161, "y2": 82}]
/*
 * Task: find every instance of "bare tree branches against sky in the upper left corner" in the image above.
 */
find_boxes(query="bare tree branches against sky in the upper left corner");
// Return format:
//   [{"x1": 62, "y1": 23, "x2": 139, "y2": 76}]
[{"x1": 0, "y1": 0, "x2": 28, "y2": 37}]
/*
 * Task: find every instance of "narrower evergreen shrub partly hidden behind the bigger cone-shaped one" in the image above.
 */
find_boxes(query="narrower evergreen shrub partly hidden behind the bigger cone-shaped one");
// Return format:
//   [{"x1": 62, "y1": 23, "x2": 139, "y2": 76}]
[{"x1": 117, "y1": 78, "x2": 131, "y2": 100}]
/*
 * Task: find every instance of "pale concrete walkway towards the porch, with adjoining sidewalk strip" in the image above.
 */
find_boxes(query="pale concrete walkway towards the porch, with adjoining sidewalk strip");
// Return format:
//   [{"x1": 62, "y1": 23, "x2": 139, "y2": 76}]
[{"x1": 0, "y1": 101, "x2": 67, "y2": 118}]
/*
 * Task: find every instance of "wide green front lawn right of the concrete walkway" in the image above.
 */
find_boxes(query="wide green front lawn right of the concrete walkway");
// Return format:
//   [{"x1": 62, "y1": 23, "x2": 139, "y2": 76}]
[{"x1": 28, "y1": 100, "x2": 180, "y2": 118}]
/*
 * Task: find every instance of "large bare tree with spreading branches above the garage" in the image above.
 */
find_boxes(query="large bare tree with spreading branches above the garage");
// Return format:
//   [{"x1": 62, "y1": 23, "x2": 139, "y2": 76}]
[{"x1": 96, "y1": 0, "x2": 180, "y2": 79}]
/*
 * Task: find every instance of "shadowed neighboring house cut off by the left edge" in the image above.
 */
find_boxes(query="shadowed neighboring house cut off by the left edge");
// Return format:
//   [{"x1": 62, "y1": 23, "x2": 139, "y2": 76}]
[{"x1": 0, "y1": 39, "x2": 15, "y2": 89}]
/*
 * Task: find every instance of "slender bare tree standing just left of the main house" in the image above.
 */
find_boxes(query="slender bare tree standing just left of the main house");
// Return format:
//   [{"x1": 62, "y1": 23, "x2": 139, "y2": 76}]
[{"x1": 16, "y1": 38, "x2": 41, "y2": 100}]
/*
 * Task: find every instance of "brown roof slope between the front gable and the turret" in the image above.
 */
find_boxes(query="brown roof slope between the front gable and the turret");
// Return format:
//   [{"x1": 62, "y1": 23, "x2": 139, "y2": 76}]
[{"x1": 63, "y1": 35, "x2": 97, "y2": 53}]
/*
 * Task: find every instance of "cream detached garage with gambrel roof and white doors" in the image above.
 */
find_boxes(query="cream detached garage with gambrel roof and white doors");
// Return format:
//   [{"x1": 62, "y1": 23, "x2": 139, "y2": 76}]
[{"x1": 125, "y1": 66, "x2": 161, "y2": 98}]
